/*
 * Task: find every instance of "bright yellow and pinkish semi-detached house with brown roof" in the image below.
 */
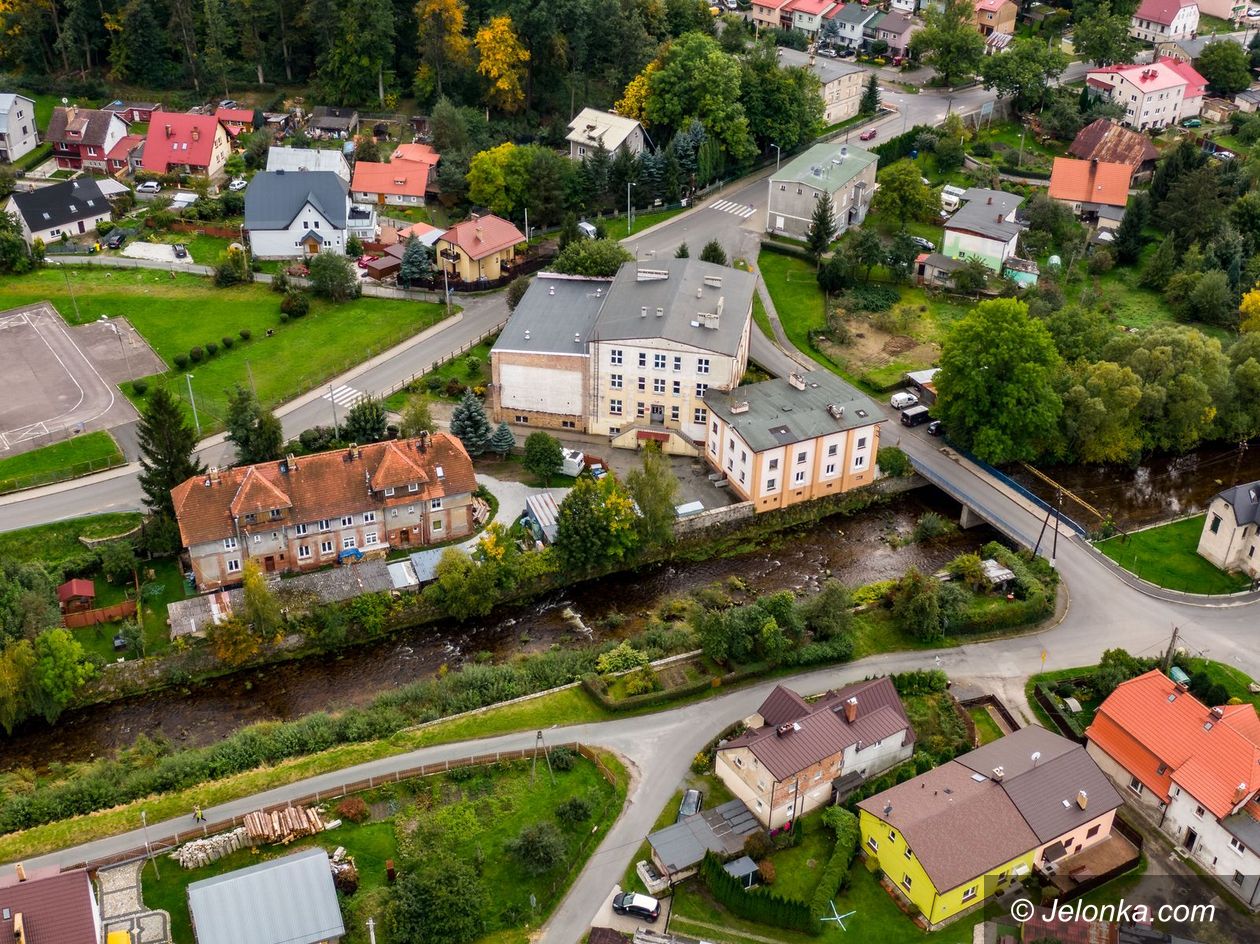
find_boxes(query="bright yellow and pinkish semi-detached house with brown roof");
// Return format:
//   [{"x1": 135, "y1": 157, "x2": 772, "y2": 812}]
[{"x1": 858, "y1": 726, "x2": 1123, "y2": 926}]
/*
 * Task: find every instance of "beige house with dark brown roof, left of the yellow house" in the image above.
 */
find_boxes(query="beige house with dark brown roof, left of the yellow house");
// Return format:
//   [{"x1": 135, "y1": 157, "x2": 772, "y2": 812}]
[{"x1": 714, "y1": 678, "x2": 915, "y2": 828}]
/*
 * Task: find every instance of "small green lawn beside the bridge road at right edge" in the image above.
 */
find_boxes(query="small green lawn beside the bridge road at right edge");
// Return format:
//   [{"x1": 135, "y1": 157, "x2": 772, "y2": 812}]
[{"x1": 1096, "y1": 514, "x2": 1250, "y2": 594}]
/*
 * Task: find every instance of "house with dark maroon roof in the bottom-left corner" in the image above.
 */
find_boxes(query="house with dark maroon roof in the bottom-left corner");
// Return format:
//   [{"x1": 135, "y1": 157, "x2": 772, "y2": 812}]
[{"x1": 0, "y1": 863, "x2": 101, "y2": 944}]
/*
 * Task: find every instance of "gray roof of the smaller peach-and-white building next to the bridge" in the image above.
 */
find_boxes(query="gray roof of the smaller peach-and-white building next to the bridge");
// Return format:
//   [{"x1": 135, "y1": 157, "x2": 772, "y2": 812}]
[{"x1": 704, "y1": 371, "x2": 883, "y2": 452}]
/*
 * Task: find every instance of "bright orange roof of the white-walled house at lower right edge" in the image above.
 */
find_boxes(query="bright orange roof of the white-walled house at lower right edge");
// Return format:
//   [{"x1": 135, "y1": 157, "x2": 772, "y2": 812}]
[{"x1": 1085, "y1": 669, "x2": 1260, "y2": 818}]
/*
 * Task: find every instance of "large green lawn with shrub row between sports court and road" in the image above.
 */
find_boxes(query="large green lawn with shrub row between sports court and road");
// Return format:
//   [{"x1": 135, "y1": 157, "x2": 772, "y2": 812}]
[{"x1": 0, "y1": 266, "x2": 444, "y2": 435}]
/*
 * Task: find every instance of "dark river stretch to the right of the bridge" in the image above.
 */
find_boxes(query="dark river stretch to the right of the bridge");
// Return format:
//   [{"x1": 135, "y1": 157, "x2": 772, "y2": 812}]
[{"x1": 1007, "y1": 442, "x2": 1260, "y2": 531}]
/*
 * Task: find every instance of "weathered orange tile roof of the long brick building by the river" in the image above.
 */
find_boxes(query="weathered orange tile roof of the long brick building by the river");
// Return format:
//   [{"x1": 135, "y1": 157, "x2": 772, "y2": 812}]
[{"x1": 170, "y1": 432, "x2": 476, "y2": 547}]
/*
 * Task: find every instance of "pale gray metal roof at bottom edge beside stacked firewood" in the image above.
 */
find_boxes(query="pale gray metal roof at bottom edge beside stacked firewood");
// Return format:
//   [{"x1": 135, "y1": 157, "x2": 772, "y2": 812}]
[{"x1": 188, "y1": 849, "x2": 345, "y2": 944}]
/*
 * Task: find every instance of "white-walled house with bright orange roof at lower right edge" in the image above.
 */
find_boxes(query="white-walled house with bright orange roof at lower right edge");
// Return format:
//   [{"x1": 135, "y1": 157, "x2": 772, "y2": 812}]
[{"x1": 1085, "y1": 669, "x2": 1260, "y2": 909}]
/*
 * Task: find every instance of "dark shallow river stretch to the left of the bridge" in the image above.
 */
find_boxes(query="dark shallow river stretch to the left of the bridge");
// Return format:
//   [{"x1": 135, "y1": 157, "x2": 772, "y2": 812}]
[{"x1": 0, "y1": 488, "x2": 998, "y2": 770}]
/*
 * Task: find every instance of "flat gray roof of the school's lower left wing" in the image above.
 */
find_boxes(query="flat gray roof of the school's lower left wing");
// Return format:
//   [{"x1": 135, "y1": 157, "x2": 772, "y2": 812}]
[{"x1": 494, "y1": 272, "x2": 612, "y2": 355}]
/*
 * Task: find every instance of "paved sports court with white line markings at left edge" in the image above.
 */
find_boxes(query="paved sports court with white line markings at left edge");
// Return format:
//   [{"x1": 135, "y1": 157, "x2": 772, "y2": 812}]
[{"x1": 0, "y1": 304, "x2": 152, "y2": 456}]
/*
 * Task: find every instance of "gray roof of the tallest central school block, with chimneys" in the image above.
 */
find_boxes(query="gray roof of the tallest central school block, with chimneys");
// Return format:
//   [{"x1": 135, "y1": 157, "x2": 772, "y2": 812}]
[{"x1": 592, "y1": 258, "x2": 757, "y2": 357}]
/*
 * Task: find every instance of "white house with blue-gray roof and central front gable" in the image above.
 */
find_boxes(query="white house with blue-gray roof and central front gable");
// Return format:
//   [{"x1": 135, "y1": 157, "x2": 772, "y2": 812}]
[{"x1": 244, "y1": 170, "x2": 350, "y2": 258}]
